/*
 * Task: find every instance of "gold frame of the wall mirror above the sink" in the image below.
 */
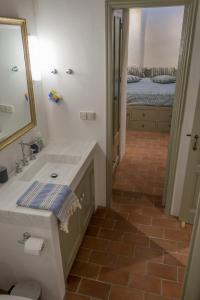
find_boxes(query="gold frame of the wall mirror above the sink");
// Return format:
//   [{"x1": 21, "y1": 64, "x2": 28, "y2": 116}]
[{"x1": 0, "y1": 17, "x2": 37, "y2": 150}]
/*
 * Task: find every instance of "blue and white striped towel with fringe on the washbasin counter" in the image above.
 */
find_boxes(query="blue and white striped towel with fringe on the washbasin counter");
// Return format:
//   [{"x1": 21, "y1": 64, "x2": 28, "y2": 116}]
[{"x1": 17, "y1": 181, "x2": 81, "y2": 233}]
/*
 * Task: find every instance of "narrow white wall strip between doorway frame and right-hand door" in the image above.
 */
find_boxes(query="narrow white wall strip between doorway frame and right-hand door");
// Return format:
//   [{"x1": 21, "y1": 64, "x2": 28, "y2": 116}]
[{"x1": 171, "y1": 3, "x2": 200, "y2": 215}]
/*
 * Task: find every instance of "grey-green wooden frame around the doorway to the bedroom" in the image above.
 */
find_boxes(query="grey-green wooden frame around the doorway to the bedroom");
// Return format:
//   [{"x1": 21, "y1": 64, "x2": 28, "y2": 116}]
[{"x1": 105, "y1": 0, "x2": 198, "y2": 214}]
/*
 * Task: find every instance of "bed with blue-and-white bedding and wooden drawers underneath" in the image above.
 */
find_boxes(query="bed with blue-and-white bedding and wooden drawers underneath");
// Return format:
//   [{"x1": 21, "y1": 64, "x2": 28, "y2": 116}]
[{"x1": 127, "y1": 69, "x2": 176, "y2": 132}]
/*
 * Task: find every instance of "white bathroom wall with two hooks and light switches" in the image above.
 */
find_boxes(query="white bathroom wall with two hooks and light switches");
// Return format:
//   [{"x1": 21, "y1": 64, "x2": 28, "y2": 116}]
[{"x1": 34, "y1": 0, "x2": 106, "y2": 205}]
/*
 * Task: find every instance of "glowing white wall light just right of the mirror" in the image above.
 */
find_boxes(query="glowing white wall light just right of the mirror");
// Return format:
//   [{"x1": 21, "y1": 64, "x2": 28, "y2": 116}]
[{"x1": 28, "y1": 35, "x2": 42, "y2": 81}]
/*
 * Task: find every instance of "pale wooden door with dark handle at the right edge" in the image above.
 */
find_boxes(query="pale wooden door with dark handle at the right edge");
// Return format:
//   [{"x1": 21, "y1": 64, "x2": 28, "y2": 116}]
[{"x1": 179, "y1": 83, "x2": 200, "y2": 224}]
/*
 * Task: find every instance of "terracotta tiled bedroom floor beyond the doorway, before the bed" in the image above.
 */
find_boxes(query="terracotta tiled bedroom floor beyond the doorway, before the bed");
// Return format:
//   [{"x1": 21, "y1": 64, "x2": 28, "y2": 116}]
[{"x1": 113, "y1": 131, "x2": 169, "y2": 195}]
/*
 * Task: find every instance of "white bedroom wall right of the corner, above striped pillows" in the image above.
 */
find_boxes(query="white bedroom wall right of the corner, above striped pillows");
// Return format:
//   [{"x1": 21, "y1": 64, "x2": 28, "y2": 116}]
[{"x1": 144, "y1": 6, "x2": 184, "y2": 67}]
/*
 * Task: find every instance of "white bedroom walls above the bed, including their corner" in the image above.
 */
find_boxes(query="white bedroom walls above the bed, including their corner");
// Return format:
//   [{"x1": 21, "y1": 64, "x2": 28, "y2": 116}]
[{"x1": 129, "y1": 6, "x2": 184, "y2": 67}]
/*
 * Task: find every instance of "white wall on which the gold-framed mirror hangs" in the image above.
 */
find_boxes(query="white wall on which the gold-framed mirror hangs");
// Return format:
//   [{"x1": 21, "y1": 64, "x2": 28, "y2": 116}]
[{"x1": 0, "y1": 0, "x2": 48, "y2": 172}]
